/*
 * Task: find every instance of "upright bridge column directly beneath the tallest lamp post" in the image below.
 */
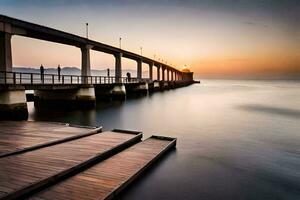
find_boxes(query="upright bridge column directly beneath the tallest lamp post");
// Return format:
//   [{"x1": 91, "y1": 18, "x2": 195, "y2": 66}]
[{"x1": 81, "y1": 45, "x2": 92, "y2": 84}]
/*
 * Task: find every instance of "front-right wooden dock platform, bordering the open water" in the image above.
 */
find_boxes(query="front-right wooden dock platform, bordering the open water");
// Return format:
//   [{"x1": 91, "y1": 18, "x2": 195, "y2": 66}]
[{"x1": 29, "y1": 136, "x2": 176, "y2": 200}]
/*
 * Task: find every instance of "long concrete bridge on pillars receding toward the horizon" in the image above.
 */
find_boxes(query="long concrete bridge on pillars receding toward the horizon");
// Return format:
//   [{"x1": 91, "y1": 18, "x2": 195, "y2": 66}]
[{"x1": 0, "y1": 15, "x2": 194, "y2": 118}]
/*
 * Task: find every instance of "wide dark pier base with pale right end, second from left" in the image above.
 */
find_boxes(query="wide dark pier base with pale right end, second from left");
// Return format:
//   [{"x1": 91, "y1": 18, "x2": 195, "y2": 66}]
[{"x1": 34, "y1": 85, "x2": 96, "y2": 109}]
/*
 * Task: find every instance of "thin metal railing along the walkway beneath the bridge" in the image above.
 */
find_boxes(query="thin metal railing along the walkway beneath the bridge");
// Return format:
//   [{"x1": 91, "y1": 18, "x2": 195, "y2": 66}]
[{"x1": 0, "y1": 71, "x2": 144, "y2": 85}]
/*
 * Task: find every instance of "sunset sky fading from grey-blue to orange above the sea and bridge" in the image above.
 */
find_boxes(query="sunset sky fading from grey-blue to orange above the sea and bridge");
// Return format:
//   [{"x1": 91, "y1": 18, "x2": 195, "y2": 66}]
[{"x1": 0, "y1": 0, "x2": 300, "y2": 79}]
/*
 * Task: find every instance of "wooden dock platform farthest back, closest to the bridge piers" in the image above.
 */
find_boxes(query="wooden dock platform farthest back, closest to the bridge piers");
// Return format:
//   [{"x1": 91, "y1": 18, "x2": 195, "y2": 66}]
[{"x1": 0, "y1": 121, "x2": 101, "y2": 158}]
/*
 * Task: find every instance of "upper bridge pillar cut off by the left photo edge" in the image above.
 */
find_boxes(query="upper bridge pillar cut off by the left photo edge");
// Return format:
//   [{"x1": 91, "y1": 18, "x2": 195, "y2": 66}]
[{"x1": 0, "y1": 32, "x2": 12, "y2": 72}]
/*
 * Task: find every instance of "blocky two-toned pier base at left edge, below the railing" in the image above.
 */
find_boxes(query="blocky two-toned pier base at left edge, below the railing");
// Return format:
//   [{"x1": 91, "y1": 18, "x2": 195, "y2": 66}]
[{"x1": 0, "y1": 88, "x2": 28, "y2": 120}]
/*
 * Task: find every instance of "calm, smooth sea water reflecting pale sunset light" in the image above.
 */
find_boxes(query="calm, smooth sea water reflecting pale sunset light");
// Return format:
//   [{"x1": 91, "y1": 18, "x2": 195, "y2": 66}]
[{"x1": 29, "y1": 80, "x2": 300, "y2": 200}]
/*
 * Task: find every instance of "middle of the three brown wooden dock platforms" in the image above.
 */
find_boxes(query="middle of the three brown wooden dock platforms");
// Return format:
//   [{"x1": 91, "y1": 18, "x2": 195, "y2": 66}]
[{"x1": 0, "y1": 131, "x2": 142, "y2": 199}]
